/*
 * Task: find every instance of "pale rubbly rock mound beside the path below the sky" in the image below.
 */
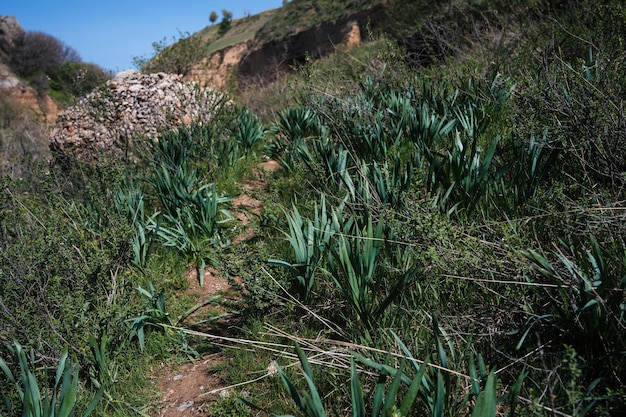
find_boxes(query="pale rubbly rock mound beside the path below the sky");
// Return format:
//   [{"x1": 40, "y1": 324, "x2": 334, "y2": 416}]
[{"x1": 50, "y1": 71, "x2": 224, "y2": 161}]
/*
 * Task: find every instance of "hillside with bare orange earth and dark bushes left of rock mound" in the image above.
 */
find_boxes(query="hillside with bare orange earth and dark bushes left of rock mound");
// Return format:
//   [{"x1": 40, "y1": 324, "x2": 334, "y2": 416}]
[{"x1": 0, "y1": 16, "x2": 110, "y2": 177}]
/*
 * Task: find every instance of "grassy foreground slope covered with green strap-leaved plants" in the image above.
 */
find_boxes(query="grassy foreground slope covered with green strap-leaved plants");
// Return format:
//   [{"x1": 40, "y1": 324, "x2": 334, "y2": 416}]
[{"x1": 0, "y1": 0, "x2": 626, "y2": 417}]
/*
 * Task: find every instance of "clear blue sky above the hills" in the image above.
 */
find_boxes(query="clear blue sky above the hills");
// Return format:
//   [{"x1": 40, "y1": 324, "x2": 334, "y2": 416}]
[{"x1": 0, "y1": 0, "x2": 283, "y2": 72}]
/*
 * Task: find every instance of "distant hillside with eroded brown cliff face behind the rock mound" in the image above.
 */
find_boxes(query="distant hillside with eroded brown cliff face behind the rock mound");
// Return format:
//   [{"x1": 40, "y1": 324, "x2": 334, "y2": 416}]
[{"x1": 149, "y1": 1, "x2": 387, "y2": 89}]
